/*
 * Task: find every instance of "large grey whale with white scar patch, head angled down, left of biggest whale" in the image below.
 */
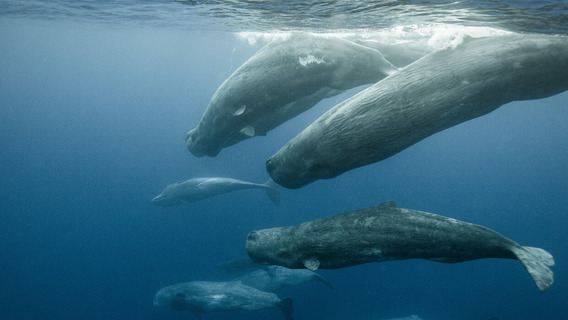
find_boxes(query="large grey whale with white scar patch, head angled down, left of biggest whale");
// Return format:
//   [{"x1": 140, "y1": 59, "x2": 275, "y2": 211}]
[{"x1": 185, "y1": 33, "x2": 397, "y2": 157}]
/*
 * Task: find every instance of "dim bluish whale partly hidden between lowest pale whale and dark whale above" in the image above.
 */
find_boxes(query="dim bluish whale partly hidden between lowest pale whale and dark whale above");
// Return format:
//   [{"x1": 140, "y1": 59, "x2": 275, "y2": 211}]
[{"x1": 236, "y1": 266, "x2": 333, "y2": 292}]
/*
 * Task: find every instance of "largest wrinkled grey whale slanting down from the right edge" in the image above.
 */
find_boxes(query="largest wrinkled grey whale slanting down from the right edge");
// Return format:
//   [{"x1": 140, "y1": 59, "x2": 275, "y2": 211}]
[{"x1": 266, "y1": 35, "x2": 568, "y2": 189}]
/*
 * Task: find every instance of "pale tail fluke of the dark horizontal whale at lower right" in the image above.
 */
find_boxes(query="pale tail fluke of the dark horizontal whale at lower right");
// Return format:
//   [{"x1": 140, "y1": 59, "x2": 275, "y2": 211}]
[{"x1": 513, "y1": 247, "x2": 554, "y2": 291}]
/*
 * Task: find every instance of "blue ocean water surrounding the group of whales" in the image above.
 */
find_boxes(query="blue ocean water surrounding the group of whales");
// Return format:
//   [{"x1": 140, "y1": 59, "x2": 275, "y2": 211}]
[{"x1": 0, "y1": 1, "x2": 568, "y2": 320}]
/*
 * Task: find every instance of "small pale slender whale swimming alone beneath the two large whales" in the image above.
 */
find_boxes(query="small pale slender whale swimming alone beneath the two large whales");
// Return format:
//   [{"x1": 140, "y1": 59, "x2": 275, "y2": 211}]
[{"x1": 152, "y1": 177, "x2": 280, "y2": 207}]
